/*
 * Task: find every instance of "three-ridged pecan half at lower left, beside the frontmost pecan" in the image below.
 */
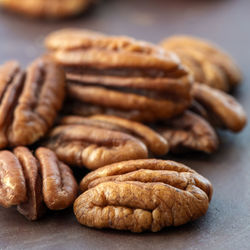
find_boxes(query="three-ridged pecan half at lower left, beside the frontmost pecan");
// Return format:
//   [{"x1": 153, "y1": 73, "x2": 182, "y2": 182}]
[{"x1": 0, "y1": 147, "x2": 78, "y2": 220}]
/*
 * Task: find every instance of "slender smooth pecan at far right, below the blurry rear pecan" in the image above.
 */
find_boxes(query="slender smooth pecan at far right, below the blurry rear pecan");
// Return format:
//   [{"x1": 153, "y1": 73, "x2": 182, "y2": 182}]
[{"x1": 192, "y1": 83, "x2": 247, "y2": 132}]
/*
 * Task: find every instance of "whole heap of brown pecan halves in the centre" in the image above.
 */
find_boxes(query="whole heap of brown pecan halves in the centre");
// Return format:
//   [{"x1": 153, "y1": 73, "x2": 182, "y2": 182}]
[{"x1": 0, "y1": 29, "x2": 246, "y2": 232}]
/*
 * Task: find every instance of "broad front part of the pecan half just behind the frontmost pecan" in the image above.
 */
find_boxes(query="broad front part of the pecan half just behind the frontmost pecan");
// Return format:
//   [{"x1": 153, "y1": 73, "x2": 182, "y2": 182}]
[{"x1": 45, "y1": 120, "x2": 148, "y2": 170}]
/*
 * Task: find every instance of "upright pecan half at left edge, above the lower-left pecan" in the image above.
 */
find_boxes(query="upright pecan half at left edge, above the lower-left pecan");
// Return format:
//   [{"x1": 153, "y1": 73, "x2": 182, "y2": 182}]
[{"x1": 0, "y1": 57, "x2": 65, "y2": 148}]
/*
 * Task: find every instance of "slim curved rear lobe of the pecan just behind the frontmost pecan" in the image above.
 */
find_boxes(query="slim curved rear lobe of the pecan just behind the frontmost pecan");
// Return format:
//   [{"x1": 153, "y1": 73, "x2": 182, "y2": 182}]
[{"x1": 61, "y1": 115, "x2": 168, "y2": 155}]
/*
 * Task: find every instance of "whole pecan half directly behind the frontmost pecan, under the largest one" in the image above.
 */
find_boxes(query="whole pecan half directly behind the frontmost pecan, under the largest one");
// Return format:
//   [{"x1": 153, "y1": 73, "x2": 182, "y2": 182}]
[{"x1": 45, "y1": 115, "x2": 168, "y2": 170}]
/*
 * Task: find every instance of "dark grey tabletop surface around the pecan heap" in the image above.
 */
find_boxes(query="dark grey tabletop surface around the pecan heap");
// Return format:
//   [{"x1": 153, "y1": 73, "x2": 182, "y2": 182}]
[{"x1": 0, "y1": 0, "x2": 250, "y2": 250}]
